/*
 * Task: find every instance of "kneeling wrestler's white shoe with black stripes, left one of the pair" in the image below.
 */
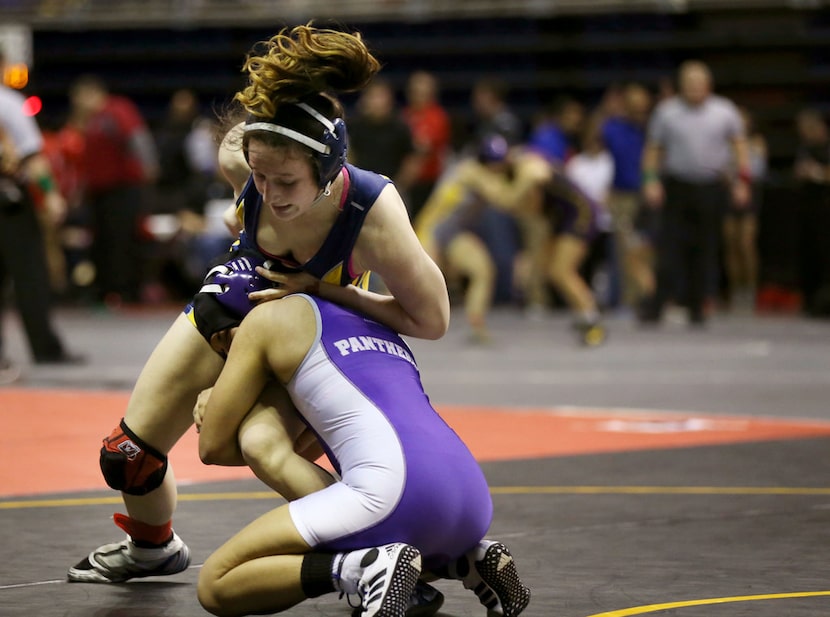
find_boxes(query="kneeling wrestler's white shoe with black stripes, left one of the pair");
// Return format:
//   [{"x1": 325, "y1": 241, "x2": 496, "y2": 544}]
[{"x1": 357, "y1": 543, "x2": 421, "y2": 617}]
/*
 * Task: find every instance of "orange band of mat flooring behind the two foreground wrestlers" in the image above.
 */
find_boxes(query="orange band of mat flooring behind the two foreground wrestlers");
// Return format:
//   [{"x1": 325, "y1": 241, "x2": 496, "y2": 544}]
[{"x1": 0, "y1": 388, "x2": 830, "y2": 497}]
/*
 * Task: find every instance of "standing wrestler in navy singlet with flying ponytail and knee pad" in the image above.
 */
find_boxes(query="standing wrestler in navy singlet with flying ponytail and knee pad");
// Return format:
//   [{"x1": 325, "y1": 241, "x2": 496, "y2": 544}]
[{"x1": 68, "y1": 25, "x2": 449, "y2": 583}]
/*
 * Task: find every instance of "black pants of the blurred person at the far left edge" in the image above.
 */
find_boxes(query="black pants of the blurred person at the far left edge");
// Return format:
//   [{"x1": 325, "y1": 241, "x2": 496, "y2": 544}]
[{"x1": 0, "y1": 191, "x2": 63, "y2": 360}]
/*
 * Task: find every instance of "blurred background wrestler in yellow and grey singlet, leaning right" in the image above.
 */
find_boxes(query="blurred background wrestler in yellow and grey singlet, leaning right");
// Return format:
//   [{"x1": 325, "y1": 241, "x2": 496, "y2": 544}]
[{"x1": 414, "y1": 134, "x2": 518, "y2": 343}]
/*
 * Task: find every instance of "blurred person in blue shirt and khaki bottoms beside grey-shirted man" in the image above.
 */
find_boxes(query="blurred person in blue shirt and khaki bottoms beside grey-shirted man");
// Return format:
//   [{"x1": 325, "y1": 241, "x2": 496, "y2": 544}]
[{"x1": 601, "y1": 83, "x2": 654, "y2": 308}]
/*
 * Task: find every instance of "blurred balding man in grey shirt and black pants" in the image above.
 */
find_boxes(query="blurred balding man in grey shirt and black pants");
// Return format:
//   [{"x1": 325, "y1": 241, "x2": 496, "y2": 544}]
[{"x1": 640, "y1": 61, "x2": 752, "y2": 325}]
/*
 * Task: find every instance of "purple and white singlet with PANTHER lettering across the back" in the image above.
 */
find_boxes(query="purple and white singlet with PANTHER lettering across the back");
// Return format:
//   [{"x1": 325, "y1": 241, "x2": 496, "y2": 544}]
[{"x1": 286, "y1": 295, "x2": 493, "y2": 568}]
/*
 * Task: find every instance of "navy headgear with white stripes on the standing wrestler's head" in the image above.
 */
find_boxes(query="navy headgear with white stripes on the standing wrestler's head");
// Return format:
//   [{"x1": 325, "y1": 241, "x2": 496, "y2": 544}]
[{"x1": 245, "y1": 103, "x2": 349, "y2": 188}]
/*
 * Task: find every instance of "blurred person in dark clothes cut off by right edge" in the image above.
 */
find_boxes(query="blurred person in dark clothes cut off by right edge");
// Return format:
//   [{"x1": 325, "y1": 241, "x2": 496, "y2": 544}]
[{"x1": 793, "y1": 108, "x2": 830, "y2": 317}]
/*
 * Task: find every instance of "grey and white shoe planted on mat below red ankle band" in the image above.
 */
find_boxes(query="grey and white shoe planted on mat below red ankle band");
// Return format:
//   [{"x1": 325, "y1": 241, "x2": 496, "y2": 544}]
[{"x1": 67, "y1": 533, "x2": 190, "y2": 583}]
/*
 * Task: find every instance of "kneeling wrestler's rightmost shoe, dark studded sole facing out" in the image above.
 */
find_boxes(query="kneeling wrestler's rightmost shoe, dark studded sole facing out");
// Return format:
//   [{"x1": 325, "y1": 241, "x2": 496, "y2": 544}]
[{"x1": 456, "y1": 540, "x2": 530, "y2": 617}]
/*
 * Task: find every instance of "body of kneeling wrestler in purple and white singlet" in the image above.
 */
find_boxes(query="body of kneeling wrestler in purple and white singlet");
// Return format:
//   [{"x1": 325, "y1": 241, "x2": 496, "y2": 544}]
[{"x1": 194, "y1": 294, "x2": 530, "y2": 617}]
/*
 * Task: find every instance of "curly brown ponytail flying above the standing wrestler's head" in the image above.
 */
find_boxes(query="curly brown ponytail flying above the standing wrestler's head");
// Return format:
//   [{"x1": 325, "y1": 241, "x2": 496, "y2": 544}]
[{"x1": 234, "y1": 24, "x2": 380, "y2": 118}]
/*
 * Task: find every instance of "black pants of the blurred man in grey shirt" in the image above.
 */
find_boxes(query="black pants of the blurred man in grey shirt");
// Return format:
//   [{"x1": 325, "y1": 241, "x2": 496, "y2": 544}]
[{"x1": 647, "y1": 178, "x2": 730, "y2": 323}]
